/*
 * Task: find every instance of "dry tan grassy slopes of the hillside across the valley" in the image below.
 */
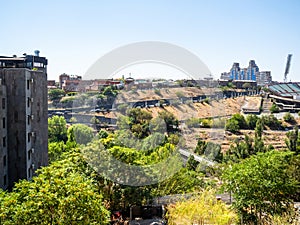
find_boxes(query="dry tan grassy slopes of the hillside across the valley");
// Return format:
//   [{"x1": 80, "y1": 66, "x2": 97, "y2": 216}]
[{"x1": 96, "y1": 87, "x2": 296, "y2": 151}]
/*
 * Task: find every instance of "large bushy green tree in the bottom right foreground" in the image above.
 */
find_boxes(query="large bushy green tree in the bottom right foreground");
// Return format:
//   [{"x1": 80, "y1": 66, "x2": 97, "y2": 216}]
[{"x1": 222, "y1": 151, "x2": 299, "y2": 222}]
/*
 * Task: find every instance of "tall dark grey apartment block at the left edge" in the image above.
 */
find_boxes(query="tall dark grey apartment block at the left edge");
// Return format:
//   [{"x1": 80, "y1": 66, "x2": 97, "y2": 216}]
[{"x1": 0, "y1": 51, "x2": 48, "y2": 189}]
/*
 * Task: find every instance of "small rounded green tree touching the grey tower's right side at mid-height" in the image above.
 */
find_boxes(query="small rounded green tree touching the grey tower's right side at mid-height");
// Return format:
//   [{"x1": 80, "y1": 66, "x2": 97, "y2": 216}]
[{"x1": 48, "y1": 116, "x2": 67, "y2": 142}]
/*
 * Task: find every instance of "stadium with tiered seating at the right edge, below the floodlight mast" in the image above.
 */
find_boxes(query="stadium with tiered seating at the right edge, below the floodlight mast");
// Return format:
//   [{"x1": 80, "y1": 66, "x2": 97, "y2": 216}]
[{"x1": 268, "y1": 82, "x2": 300, "y2": 111}]
